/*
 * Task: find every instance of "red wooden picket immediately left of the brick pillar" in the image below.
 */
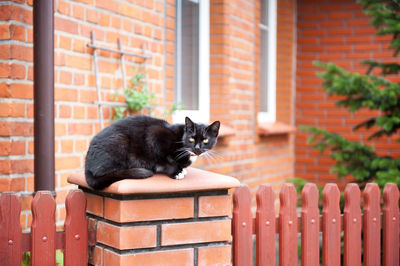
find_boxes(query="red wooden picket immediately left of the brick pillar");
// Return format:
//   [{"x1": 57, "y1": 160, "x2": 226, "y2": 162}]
[{"x1": 64, "y1": 190, "x2": 88, "y2": 266}]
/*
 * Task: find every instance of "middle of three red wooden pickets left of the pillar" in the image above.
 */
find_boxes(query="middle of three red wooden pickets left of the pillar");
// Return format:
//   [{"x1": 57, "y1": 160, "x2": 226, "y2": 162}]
[{"x1": 31, "y1": 191, "x2": 56, "y2": 266}]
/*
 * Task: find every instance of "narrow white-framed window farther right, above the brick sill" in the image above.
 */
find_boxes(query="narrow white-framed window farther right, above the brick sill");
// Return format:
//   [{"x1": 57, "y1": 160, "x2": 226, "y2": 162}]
[{"x1": 258, "y1": 0, "x2": 276, "y2": 122}]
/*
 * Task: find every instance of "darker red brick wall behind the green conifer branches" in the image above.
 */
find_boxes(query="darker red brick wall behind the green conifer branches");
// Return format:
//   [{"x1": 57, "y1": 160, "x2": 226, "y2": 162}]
[{"x1": 296, "y1": 1, "x2": 398, "y2": 185}]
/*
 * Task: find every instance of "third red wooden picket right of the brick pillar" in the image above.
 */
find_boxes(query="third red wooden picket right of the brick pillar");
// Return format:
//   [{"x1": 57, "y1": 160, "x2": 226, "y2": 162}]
[{"x1": 279, "y1": 184, "x2": 298, "y2": 266}]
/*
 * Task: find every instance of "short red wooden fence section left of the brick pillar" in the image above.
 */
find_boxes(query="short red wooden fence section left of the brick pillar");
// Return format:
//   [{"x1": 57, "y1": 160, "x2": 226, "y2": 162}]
[{"x1": 0, "y1": 190, "x2": 93, "y2": 266}]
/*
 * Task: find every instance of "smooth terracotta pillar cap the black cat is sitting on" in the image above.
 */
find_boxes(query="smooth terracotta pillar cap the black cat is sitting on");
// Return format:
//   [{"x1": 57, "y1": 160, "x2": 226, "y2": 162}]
[{"x1": 68, "y1": 167, "x2": 240, "y2": 195}]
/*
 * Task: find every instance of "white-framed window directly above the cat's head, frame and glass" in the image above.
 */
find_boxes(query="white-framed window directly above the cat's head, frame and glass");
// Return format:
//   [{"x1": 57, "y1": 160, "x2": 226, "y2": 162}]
[{"x1": 173, "y1": 0, "x2": 210, "y2": 123}]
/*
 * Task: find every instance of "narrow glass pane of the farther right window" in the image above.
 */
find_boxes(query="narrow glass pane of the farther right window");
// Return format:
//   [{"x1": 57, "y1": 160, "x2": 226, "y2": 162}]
[{"x1": 259, "y1": 30, "x2": 268, "y2": 112}]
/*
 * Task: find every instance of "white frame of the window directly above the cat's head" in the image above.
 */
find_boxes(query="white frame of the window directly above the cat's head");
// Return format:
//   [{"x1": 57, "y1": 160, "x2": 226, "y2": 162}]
[{"x1": 172, "y1": 0, "x2": 210, "y2": 123}]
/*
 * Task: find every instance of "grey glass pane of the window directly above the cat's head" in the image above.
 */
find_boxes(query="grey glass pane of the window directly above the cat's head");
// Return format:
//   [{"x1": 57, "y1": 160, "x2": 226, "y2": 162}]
[{"x1": 179, "y1": 0, "x2": 199, "y2": 110}]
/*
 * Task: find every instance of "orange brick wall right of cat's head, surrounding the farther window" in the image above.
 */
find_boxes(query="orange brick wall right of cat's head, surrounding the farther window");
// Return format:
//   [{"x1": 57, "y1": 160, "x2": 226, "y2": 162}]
[{"x1": 205, "y1": 0, "x2": 295, "y2": 197}]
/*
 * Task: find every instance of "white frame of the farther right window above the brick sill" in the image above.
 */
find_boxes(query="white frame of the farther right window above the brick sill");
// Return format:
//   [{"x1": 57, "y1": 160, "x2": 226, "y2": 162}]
[{"x1": 258, "y1": 0, "x2": 277, "y2": 123}]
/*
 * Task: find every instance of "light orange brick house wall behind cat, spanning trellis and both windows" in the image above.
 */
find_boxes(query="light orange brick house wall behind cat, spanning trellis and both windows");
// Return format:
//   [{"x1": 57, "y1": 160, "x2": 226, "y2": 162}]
[{"x1": 0, "y1": 0, "x2": 295, "y2": 230}]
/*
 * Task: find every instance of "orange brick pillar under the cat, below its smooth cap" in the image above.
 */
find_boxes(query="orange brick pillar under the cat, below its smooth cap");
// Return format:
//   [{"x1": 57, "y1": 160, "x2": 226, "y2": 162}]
[{"x1": 86, "y1": 188, "x2": 232, "y2": 265}]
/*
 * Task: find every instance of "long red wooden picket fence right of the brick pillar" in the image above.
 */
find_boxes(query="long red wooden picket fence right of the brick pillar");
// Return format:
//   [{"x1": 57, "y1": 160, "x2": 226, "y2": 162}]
[{"x1": 232, "y1": 184, "x2": 400, "y2": 266}]
